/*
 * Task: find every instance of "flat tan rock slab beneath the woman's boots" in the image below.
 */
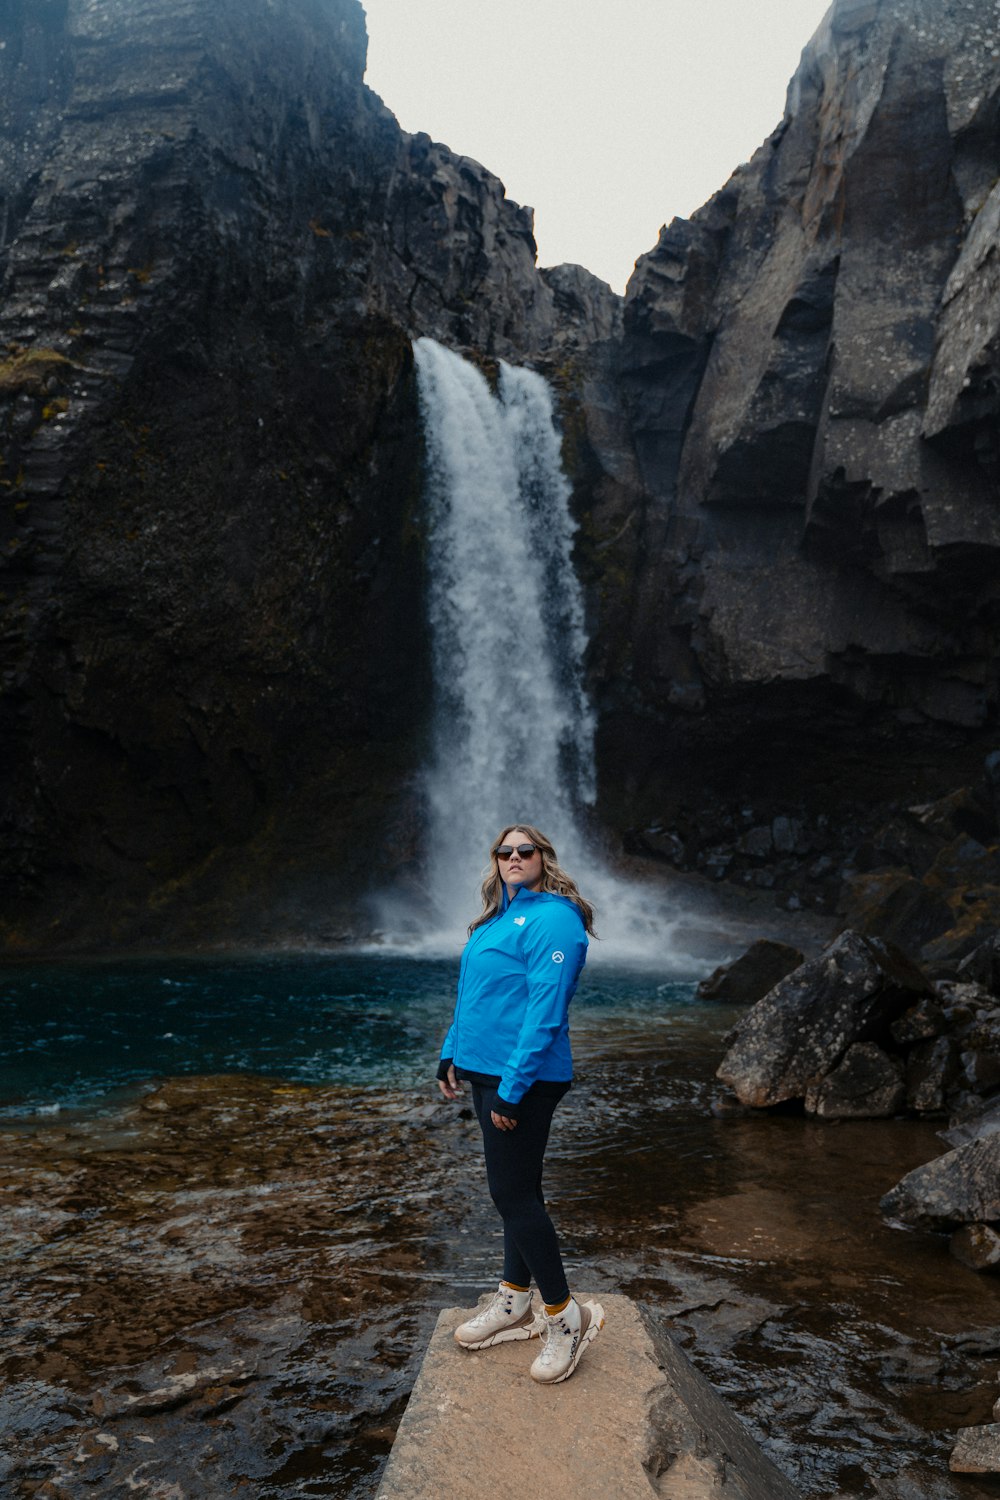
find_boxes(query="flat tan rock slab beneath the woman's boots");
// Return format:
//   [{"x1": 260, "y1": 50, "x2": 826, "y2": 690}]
[{"x1": 376, "y1": 1293, "x2": 798, "y2": 1500}]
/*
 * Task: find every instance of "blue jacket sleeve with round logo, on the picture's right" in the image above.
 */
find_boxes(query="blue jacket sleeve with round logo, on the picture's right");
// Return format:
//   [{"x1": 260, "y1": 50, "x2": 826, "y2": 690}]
[{"x1": 498, "y1": 902, "x2": 586, "y2": 1115}]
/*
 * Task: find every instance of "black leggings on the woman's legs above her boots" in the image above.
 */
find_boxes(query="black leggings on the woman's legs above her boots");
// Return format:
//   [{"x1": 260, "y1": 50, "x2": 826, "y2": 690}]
[{"x1": 472, "y1": 1083, "x2": 570, "y2": 1307}]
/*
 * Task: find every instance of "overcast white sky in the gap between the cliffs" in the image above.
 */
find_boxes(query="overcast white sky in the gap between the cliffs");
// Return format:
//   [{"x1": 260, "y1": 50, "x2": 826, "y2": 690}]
[{"x1": 363, "y1": 0, "x2": 829, "y2": 291}]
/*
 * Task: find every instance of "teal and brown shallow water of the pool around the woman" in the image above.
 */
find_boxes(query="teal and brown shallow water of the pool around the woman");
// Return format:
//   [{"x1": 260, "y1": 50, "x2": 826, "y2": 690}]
[{"x1": 0, "y1": 957, "x2": 1000, "y2": 1500}]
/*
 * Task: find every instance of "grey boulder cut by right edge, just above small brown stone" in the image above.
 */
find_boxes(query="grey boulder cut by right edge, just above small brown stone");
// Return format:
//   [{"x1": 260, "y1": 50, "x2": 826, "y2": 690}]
[{"x1": 880, "y1": 1133, "x2": 1000, "y2": 1230}]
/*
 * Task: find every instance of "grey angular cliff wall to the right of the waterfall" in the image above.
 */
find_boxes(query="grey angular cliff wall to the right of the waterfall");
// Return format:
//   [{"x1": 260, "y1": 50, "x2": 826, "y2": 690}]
[{"x1": 581, "y1": 0, "x2": 1000, "y2": 810}]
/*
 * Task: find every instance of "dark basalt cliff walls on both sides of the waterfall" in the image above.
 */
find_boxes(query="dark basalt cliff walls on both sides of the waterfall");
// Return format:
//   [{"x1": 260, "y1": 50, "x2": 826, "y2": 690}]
[{"x1": 0, "y1": 0, "x2": 1000, "y2": 953}]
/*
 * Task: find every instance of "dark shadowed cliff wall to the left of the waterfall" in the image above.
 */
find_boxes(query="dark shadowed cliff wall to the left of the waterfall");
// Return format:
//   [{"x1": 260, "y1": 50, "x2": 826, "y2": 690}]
[{"x1": 0, "y1": 0, "x2": 590, "y2": 950}]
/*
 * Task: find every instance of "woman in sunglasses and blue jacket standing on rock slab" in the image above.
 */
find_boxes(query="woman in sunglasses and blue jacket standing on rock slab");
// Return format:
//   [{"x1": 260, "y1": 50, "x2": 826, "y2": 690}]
[{"x1": 438, "y1": 824, "x2": 604, "y2": 1385}]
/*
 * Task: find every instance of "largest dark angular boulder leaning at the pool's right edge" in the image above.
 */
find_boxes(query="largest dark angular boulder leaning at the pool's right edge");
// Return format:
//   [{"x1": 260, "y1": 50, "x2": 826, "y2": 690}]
[{"x1": 717, "y1": 932, "x2": 933, "y2": 1107}]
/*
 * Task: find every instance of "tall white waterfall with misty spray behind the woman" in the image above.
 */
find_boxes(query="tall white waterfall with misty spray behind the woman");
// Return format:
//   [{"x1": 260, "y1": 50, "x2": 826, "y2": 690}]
[{"x1": 374, "y1": 339, "x2": 710, "y2": 972}]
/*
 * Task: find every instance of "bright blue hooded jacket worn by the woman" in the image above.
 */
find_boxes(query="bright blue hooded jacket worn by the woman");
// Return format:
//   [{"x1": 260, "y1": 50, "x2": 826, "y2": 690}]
[{"x1": 439, "y1": 887, "x2": 588, "y2": 1113}]
